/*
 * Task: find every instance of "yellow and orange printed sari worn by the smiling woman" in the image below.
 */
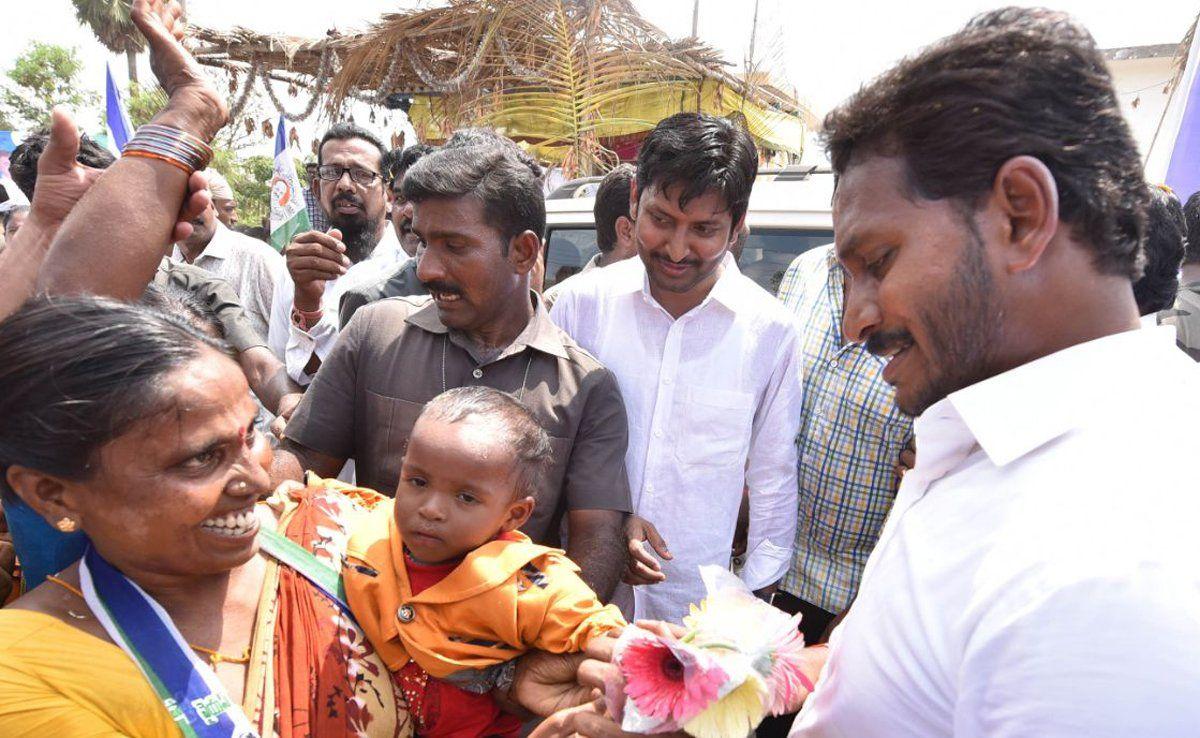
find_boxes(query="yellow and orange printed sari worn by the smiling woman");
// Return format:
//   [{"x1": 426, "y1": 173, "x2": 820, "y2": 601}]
[{"x1": 0, "y1": 485, "x2": 414, "y2": 738}]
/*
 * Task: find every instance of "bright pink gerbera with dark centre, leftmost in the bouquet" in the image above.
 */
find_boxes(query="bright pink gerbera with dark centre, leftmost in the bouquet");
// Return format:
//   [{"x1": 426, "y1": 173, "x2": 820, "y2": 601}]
[{"x1": 620, "y1": 636, "x2": 730, "y2": 725}]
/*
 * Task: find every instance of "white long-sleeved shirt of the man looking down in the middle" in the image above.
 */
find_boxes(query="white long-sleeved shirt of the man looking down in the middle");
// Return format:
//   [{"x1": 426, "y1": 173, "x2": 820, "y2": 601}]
[{"x1": 551, "y1": 254, "x2": 800, "y2": 623}]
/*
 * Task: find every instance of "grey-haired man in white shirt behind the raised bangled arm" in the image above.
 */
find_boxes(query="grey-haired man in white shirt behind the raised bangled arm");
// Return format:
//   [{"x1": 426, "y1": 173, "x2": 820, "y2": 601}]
[{"x1": 170, "y1": 190, "x2": 287, "y2": 338}]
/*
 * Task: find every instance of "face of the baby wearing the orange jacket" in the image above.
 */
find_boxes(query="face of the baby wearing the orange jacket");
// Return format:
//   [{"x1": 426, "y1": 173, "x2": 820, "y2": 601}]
[{"x1": 396, "y1": 415, "x2": 533, "y2": 564}]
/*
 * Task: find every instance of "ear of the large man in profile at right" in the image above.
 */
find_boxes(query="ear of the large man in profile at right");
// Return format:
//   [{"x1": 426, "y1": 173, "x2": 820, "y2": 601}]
[{"x1": 988, "y1": 156, "x2": 1058, "y2": 274}]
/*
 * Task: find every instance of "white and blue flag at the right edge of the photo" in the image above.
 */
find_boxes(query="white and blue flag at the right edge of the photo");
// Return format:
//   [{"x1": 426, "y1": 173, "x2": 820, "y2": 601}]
[{"x1": 1146, "y1": 22, "x2": 1200, "y2": 200}]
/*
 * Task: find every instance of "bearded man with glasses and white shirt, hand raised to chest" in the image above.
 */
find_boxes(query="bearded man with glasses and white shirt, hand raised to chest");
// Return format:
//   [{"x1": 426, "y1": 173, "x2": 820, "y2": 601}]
[{"x1": 268, "y1": 122, "x2": 408, "y2": 384}]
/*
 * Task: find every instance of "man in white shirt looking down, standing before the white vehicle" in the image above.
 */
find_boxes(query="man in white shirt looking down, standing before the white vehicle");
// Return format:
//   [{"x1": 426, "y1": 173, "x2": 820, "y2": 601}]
[{"x1": 551, "y1": 113, "x2": 800, "y2": 622}]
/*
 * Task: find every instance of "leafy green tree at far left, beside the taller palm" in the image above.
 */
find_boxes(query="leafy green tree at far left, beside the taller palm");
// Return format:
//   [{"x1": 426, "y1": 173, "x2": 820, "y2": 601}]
[{"x1": 0, "y1": 41, "x2": 100, "y2": 127}]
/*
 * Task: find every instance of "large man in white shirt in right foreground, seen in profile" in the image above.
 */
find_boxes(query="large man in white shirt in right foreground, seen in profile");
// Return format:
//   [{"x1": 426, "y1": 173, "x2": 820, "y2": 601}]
[{"x1": 792, "y1": 8, "x2": 1200, "y2": 738}]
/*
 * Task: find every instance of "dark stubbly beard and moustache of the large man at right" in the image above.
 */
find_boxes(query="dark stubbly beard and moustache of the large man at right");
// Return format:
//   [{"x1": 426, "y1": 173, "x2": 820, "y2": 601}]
[{"x1": 866, "y1": 216, "x2": 1003, "y2": 415}]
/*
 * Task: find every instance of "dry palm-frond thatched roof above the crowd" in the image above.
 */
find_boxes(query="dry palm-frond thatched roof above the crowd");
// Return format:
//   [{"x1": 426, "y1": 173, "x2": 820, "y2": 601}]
[{"x1": 193, "y1": 0, "x2": 816, "y2": 172}]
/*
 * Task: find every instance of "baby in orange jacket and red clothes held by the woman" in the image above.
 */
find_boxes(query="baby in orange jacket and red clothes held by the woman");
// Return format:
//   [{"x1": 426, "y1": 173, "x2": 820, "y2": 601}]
[{"x1": 343, "y1": 386, "x2": 625, "y2": 738}]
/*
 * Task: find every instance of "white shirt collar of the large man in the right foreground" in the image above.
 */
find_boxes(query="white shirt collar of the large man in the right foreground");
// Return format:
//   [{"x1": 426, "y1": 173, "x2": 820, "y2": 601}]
[{"x1": 917, "y1": 328, "x2": 1178, "y2": 467}]
